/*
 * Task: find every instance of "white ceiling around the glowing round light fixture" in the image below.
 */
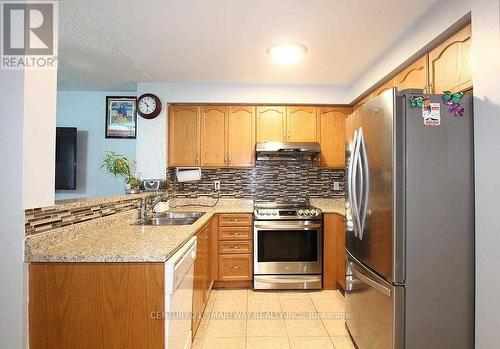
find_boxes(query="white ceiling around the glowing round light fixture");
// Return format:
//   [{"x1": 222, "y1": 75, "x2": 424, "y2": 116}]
[{"x1": 59, "y1": 0, "x2": 435, "y2": 90}]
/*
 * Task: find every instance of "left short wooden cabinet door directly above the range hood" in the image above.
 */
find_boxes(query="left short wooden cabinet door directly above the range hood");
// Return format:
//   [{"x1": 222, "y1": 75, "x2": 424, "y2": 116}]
[{"x1": 256, "y1": 106, "x2": 286, "y2": 142}]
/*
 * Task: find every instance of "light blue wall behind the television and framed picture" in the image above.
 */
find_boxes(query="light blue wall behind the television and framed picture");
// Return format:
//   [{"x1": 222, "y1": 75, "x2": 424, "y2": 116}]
[{"x1": 52, "y1": 91, "x2": 137, "y2": 200}]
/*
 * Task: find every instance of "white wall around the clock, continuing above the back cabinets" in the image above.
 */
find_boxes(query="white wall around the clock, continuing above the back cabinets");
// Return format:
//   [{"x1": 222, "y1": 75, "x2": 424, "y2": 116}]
[{"x1": 136, "y1": 83, "x2": 350, "y2": 179}]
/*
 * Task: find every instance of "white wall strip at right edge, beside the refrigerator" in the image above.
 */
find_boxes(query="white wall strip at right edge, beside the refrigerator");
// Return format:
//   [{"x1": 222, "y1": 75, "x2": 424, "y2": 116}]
[{"x1": 472, "y1": 0, "x2": 500, "y2": 349}]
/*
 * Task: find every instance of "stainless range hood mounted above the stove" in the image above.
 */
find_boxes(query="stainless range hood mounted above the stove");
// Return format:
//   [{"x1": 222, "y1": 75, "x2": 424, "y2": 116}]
[{"x1": 255, "y1": 142, "x2": 321, "y2": 161}]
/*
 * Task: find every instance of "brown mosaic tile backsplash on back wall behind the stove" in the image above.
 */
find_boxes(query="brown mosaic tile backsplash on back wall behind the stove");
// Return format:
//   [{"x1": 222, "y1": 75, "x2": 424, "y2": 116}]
[{"x1": 167, "y1": 161, "x2": 344, "y2": 202}]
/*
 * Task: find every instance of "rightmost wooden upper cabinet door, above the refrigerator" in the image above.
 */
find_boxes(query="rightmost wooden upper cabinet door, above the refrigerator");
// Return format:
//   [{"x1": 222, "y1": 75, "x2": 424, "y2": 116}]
[{"x1": 429, "y1": 25, "x2": 472, "y2": 93}]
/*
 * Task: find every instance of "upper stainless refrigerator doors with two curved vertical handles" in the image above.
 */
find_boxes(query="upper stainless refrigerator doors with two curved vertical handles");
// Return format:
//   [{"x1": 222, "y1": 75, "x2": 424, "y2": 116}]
[{"x1": 346, "y1": 89, "x2": 404, "y2": 283}]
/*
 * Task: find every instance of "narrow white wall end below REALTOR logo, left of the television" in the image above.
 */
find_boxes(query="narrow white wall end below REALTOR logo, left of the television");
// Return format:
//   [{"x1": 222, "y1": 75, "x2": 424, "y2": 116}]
[{"x1": 22, "y1": 69, "x2": 57, "y2": 208}]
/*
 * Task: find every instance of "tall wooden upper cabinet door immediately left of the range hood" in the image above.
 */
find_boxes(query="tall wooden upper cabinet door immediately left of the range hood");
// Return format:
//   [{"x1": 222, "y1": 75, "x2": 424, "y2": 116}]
[{"x1": 227, "y1": 106, "x2": 255, "y2": 167}]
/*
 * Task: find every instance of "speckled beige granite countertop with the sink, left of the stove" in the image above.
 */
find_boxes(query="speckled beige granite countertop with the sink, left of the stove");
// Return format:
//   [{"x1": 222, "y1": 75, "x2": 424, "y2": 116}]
[{"x1": 25, "y1": 199, "x2": 253, "y2": 263}]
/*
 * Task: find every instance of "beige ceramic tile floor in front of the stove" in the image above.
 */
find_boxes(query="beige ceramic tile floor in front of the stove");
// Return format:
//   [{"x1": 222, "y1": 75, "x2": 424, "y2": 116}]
[{"x1": 193, "y1": 290, "x2": 354, "y2": 349}]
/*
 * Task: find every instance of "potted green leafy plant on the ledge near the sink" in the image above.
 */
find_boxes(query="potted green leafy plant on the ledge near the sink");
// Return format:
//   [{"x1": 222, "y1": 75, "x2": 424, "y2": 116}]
[{"x1": 100, "y1": 151, "x2": 141, "y2": 194}]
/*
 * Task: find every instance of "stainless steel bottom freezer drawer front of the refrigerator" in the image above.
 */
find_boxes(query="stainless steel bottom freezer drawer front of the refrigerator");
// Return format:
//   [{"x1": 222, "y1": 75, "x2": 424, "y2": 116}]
[{"x1": 345, "y1": 252, "x2": 404, "y2": 349}]
